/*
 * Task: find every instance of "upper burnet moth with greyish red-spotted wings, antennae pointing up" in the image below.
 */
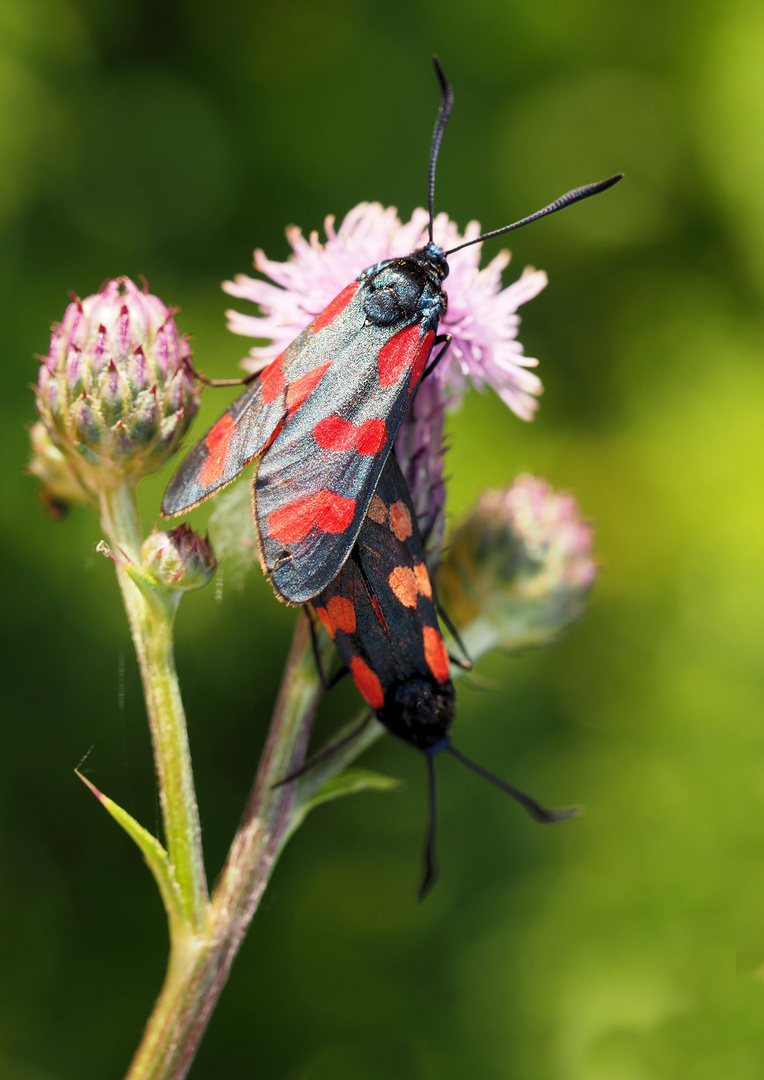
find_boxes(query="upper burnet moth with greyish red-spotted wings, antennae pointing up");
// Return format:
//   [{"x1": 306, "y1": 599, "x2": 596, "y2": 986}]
[{"x1": 162, "y1": 59, "x2": 622, "y2": 604}]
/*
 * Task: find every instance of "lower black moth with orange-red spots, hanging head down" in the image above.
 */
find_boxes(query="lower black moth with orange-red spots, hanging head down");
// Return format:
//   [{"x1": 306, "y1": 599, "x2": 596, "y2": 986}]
[{"x1": 304, "y1": 454, "x2": 574, "y2": 899}]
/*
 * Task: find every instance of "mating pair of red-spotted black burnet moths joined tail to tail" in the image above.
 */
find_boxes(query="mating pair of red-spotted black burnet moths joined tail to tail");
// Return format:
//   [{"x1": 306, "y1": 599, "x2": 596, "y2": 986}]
[{"x1": 162, "y1": 60, "x2": 620, "y2": 896}]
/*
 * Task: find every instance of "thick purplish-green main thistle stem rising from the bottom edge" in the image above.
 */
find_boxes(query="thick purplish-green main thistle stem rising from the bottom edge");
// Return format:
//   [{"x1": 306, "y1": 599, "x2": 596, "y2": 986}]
[{"x1": 128, "y1": 618, "x2": 320, "y2": 1080}]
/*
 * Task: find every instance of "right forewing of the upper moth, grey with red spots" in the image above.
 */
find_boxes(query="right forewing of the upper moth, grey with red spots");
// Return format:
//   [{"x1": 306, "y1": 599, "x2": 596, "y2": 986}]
[{"x1": 255, "y1": 319, "x2": 434, "y2": 604}]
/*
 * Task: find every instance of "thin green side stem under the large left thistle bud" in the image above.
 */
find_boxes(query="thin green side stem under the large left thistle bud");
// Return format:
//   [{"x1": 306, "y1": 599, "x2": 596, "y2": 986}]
[{"x1": 100, "y1": 484, "x2": 209, "y2": 933}]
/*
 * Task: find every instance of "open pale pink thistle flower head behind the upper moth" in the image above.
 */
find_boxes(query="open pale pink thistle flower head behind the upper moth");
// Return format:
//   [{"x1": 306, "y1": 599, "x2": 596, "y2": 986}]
[{"x1": 223, "y1": 203, "x2": 547, "y2": 552}]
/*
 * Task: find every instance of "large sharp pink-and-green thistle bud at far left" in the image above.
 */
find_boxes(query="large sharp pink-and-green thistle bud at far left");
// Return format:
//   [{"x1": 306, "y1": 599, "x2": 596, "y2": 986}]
[{"x1": 37, "y1": 278, "x2": 199, "y2": 492}]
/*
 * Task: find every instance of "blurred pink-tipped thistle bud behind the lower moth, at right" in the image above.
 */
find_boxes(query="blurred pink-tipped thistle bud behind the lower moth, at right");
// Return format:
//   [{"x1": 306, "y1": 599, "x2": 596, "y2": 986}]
[{"x1": 438, "y1": 476, "x2": 597, "y2": 654}]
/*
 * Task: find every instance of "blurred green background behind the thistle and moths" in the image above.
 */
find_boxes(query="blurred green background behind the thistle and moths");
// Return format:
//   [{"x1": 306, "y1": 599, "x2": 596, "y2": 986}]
[{"x1": 0, "y1": 0, "x2": 764, "y2": 1080}]
